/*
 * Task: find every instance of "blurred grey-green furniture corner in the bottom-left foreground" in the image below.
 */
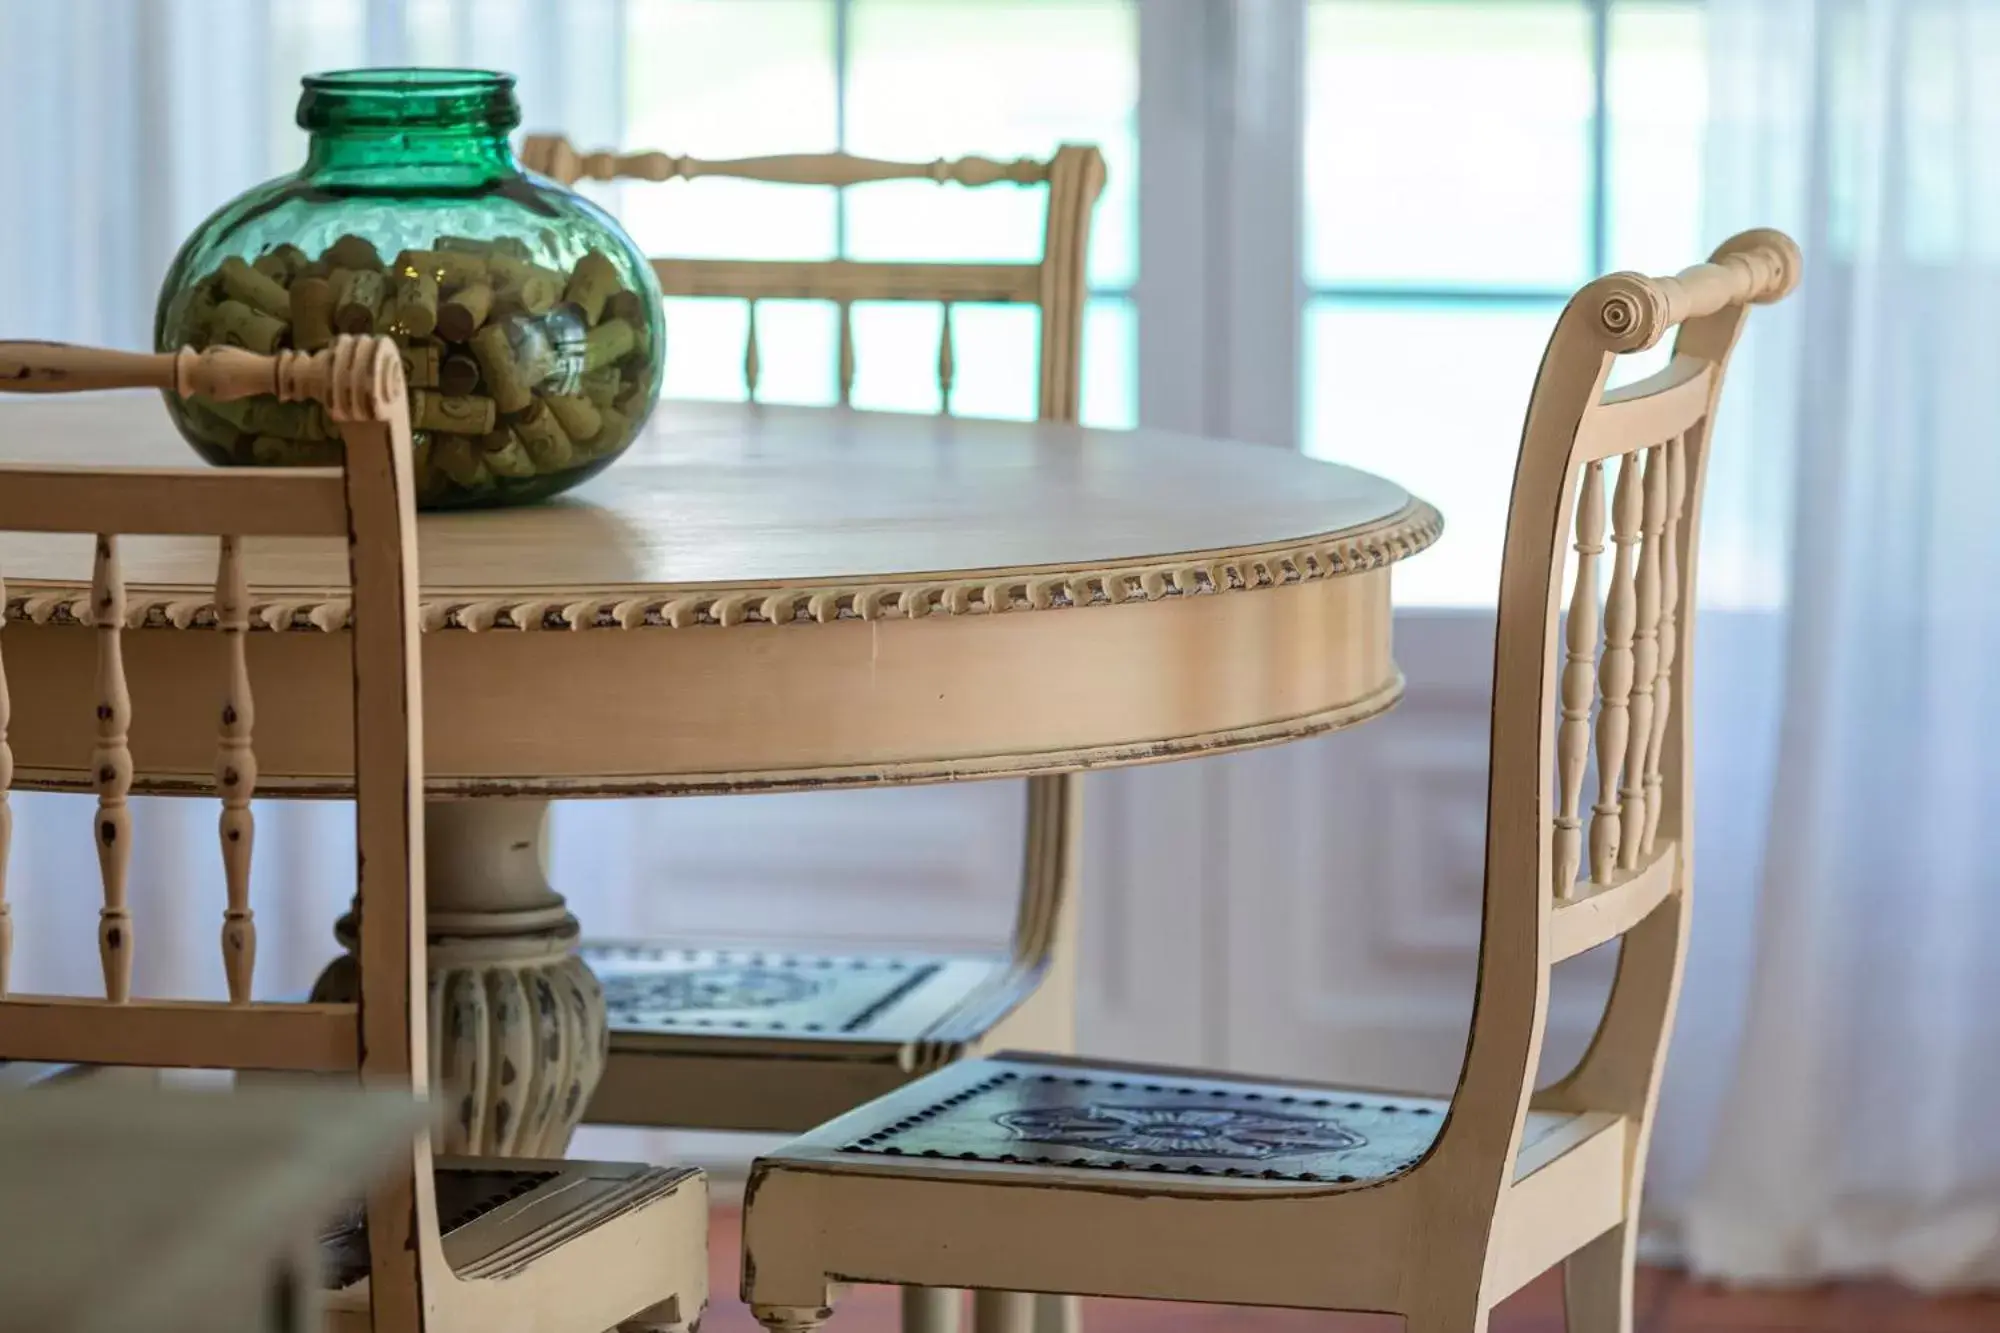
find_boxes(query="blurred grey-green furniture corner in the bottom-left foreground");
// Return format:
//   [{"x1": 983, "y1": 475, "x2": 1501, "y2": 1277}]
[{"x1": 0, "y1": 1079, "x2": 426, "y2": 1333}]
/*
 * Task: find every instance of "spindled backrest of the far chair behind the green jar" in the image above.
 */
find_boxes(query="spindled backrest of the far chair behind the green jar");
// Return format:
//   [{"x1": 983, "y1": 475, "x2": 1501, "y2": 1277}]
[{"x1": 520, "y1": 134, "x2": 1104, "y2": 422}]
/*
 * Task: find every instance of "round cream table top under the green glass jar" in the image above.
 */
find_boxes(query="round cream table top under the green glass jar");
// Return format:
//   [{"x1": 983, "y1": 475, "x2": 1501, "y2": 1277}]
[{"x1": 0, "y1": 392, "x2": 1436, "y2": 628}]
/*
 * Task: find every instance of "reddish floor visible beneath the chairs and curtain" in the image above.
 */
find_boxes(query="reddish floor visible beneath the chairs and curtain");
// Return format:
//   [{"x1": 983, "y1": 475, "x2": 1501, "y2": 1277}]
[{"x1": 702, "y1": 1209, "x2": 2000, "y2": 1333}]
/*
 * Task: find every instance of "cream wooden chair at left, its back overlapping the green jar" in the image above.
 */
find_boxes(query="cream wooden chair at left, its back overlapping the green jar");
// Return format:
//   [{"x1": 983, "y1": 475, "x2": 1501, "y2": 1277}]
[{"x1": 0, "y1": 338, "x2": 706, "y2": 1333}]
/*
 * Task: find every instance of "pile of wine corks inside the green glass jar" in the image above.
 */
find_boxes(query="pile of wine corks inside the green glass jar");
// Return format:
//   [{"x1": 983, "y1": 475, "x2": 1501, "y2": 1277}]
[{"x1": 172, "y1": 236, "x2": 652, "y2": 500}]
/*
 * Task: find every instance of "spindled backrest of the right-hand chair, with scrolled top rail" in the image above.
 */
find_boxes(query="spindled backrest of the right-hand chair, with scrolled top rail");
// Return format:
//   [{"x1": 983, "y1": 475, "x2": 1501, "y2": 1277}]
[{"x1": 1438, "y1": 230, "x2": 1802, "y2": 1187}]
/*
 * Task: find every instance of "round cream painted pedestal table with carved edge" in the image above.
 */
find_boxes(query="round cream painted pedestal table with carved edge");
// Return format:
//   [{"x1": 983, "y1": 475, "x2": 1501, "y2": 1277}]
[{"x1": 0, "y1": 394, "x2": 1440, "y2": 1143}]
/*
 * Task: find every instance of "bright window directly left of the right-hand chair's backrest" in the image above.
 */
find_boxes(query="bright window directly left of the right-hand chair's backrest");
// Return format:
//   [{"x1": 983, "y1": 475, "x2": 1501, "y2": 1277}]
[{"x1": 1302, "y1": 0, "x2": 1706, "y2": 606}]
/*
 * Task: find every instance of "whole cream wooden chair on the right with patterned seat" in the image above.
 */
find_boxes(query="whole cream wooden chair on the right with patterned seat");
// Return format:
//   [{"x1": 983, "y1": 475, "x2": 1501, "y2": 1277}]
[{"x1": 744, "y1": 232, "x2": 1800, "y2": 1333}]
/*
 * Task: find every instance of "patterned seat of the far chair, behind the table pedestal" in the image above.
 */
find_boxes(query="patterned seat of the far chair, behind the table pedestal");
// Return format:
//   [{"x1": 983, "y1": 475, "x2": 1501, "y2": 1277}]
[{"x1": 580, "y1": 943, "x2": 1008, "y2": 1049}]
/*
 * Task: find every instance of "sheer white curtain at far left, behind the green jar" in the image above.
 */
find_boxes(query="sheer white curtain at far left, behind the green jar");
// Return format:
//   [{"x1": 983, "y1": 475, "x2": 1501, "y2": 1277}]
[{"x1": 0, "y1": 0, "x2": 628, "y2": 997}]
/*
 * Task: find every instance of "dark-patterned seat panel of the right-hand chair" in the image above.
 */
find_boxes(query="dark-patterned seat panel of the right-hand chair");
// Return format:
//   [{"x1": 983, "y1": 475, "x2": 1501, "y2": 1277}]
[{"x1": 768, "y1": 1053, "x2": 1578, "y2": 1185}]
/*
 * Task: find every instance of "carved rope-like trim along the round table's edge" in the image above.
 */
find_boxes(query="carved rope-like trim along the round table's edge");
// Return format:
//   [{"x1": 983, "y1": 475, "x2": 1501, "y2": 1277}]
[{"x1": 0, "y1": 500, "x2": 1444, "y2": 632}]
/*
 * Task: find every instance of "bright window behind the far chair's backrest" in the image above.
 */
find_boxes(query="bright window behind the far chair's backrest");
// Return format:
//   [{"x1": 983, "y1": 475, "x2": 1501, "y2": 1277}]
[{"x1": 620, "y1": 0, "x2": 1138, "y2": 426}]
